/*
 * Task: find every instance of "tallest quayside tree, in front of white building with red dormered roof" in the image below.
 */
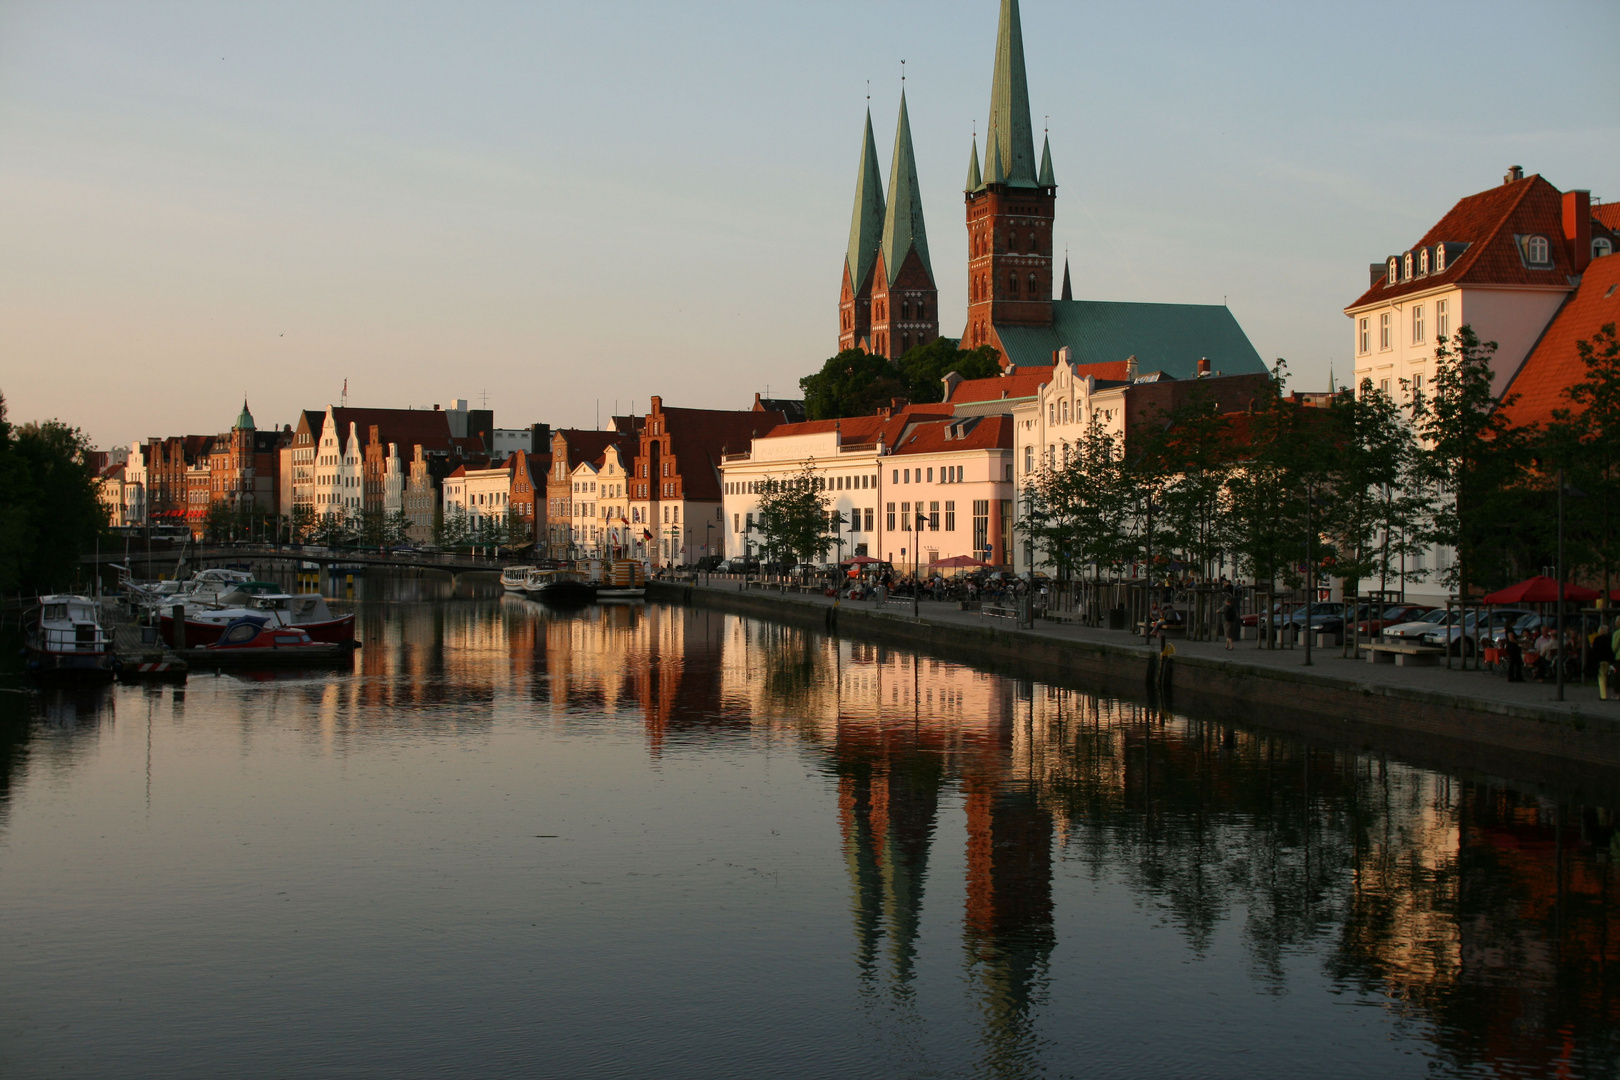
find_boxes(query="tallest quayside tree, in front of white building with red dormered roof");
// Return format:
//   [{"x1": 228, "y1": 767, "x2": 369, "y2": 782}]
[{"x1": 1411, "y1": 325, "x2": 1534, "y2": 599}]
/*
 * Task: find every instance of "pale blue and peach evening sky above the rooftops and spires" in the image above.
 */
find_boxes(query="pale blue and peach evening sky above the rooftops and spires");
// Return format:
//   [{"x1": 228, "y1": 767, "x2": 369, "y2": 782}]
[{"x1": 0, "y1": 0, "x2": 1620, "y2": 447}]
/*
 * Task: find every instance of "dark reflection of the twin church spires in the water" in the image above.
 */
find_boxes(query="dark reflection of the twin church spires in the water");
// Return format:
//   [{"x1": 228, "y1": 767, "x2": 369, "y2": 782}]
[{"x1": 838, "y1": 742, "x2": 944, "y2": 984}]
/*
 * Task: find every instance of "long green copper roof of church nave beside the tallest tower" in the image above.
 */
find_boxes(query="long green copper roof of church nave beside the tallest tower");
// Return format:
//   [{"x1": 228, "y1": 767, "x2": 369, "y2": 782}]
[{"x1": 996, "y1": 300, "x2": 1265, "y2": 379}]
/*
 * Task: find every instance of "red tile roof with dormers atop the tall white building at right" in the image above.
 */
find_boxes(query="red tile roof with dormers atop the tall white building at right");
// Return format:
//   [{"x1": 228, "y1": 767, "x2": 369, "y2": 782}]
[{"x1": 1346, "y1": 175, "x2": 1575, "y2": 311}]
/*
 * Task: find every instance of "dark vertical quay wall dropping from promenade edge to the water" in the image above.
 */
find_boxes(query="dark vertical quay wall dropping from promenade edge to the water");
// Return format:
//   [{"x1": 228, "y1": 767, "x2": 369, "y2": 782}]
[{"x1": 648, "y1": 581, "x2": 1620, "y2": 793}]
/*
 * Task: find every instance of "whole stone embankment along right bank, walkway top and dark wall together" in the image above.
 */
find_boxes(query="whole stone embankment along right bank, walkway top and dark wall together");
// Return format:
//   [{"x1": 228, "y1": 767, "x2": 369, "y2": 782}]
[{"x1": 648, "y1": 578, "x2": 1620, "y2": 790}]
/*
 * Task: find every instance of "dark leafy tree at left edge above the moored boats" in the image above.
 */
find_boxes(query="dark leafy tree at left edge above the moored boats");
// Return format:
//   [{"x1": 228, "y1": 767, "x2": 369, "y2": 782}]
[{"x1": 0, "y1": 395, "x2": 107, "y2": 593}]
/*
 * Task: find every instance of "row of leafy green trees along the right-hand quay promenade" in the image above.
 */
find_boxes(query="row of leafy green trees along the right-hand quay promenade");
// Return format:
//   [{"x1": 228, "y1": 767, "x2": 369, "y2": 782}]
[{"x1": 1019, "y1": 324, "x2": 1620, "y2": 634}]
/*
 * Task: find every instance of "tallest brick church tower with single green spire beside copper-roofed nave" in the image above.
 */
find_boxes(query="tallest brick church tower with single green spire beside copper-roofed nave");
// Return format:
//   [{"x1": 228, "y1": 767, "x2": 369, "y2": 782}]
[{"x1": 962, "y1": 0, "x2": 1058, "y2": 356}]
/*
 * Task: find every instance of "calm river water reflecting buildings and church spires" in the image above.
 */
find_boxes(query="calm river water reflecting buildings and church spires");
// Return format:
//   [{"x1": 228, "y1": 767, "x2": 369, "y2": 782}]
[{"x1": 0, "y1": 581, "x2": 1620, "y2": 1078}]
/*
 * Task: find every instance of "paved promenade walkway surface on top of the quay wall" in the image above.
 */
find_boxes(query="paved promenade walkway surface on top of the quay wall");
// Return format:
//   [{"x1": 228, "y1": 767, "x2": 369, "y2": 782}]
[{"x1": 673, "y1": 575, "x2": 1620, "y2": 724}]
